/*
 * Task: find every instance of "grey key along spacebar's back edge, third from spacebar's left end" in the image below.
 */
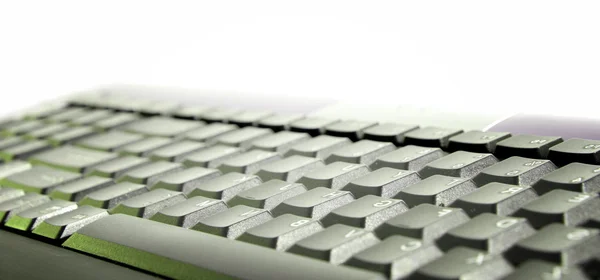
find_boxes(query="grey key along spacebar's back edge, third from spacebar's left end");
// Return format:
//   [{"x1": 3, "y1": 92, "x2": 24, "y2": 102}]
[{"x1": 192, "y1": 205, "x2": 272, "y2": 239}]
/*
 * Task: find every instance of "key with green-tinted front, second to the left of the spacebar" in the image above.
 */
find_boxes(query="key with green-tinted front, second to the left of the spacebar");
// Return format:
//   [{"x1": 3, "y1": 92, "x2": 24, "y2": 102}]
[{"x1": 5, "y1": 200, "x2": 77, "y2": 231}]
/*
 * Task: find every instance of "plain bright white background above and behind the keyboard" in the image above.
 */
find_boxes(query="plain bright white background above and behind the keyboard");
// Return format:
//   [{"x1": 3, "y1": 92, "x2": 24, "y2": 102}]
[{"x1": 0, "y1": 0, "x2": 600, "y2": 115}]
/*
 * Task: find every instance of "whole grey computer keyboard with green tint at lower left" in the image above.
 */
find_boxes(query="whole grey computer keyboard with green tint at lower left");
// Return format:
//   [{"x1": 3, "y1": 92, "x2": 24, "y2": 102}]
[{"x1": 0, "y1": 94, "x2": 600, "y2": 280}]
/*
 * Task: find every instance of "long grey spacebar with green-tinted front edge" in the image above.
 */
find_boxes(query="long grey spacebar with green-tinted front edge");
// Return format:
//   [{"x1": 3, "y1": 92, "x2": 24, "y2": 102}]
[{"x1": 63, "y1": 214, "x2": 384, "y2": 280}]
